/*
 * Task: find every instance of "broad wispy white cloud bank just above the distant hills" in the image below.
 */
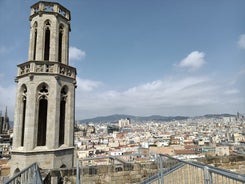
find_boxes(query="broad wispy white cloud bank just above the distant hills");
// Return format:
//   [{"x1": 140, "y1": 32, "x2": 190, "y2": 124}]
[{"x1": 76, "y1": 76, "x2": 244, "y2": 119}]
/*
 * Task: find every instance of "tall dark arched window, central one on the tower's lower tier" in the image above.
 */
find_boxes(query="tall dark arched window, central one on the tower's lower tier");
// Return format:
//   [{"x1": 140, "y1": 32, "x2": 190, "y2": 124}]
[{"x1": 37, "y1": 85, "x2": 48, "y2": 146}]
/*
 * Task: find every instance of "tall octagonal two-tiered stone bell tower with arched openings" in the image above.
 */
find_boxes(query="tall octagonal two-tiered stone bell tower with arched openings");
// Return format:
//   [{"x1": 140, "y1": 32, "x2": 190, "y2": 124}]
[{"x1": 11, "y1": 1, "x2": 76, "y2": 174}]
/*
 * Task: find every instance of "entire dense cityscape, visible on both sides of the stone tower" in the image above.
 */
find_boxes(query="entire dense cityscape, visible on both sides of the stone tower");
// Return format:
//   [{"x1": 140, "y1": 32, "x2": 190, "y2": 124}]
[{"x1": 0, "y1": 110, "x2": 245, "y2": 183}]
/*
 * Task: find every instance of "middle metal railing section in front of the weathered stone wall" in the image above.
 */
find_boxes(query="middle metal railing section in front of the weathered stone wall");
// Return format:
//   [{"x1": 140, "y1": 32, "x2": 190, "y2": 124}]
[{"x1": 76, "y1": 154, "x2": 158, "y2": 184}]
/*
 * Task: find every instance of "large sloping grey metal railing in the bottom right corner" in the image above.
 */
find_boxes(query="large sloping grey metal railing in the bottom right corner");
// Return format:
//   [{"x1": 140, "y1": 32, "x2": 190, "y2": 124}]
[{"x1": 141, "y1": 154, "x2": 245, "y2": 184}]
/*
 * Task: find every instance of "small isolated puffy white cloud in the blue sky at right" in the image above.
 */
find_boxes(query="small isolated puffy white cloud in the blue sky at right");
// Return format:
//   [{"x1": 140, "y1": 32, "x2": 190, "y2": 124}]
[{"x1": 177, "y1": 51, "x2": 205, "y2": 71}]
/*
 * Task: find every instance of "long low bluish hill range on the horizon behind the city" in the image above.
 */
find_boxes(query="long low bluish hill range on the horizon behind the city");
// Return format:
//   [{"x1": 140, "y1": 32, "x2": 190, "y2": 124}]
[{"x1": 78, "y1": 114, "x2": 235, "y2": 123}]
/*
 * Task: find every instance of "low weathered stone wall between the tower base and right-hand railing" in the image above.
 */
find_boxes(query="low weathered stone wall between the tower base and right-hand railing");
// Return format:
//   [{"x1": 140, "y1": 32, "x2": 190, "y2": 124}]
[{"x1": 47, "y1": 163, "x2": 157, "y2": 184}]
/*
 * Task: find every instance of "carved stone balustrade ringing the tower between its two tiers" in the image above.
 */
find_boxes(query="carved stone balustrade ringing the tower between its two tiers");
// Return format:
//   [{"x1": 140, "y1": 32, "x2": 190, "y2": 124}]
[{"x1": 17, "y1": 61, "x2": 76, "y2": 79}]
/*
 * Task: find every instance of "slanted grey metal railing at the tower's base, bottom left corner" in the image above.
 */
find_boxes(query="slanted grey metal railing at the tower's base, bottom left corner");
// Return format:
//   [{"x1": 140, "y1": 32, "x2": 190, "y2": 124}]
[{"x1": 5, "y1": 163, "x2": 43, "y2": 184}]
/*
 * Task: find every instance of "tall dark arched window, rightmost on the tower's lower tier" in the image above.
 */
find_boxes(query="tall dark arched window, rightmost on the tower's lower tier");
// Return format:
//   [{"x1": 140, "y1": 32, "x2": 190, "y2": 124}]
[{"x1": 59, "y1": 87, "x2": 67, "y2": 145}]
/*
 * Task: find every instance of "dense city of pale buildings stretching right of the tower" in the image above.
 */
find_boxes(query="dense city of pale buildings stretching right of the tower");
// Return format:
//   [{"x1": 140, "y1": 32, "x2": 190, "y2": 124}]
[{"x1": 75, "y1": 113, "x2": 245, "y2": 172}]
